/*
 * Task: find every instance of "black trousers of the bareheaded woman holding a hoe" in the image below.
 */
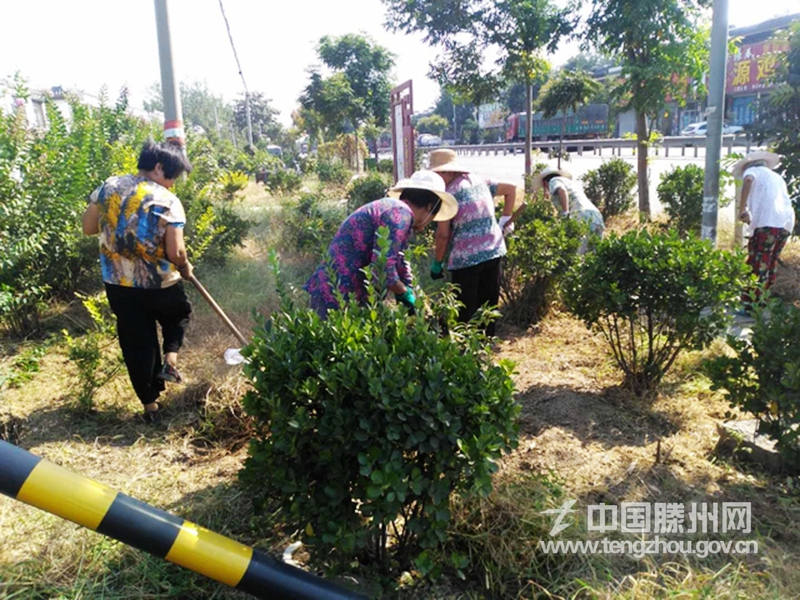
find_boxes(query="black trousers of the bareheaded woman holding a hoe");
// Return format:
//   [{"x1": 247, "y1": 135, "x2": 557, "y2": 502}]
[{"x1": 106, "y1": 281, "x2": 192, "y2": 404}]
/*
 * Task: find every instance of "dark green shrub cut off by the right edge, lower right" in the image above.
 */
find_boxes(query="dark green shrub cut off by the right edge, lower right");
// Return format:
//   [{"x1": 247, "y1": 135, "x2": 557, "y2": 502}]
[{"x1": 707, "y1": 298, "x2": 800, "y2": 471}]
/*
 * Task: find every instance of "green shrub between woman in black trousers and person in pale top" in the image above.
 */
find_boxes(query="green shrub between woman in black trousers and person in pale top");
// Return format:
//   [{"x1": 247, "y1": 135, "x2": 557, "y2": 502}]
[{"x1": 500, "y1": 200, "x2": 587, "y2": 327}]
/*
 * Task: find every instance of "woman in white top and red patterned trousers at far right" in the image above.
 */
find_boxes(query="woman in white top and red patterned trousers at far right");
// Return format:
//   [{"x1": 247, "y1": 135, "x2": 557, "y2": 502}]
[{"x1": 733, "y1": 151, "x2": 795, "y2": 312}]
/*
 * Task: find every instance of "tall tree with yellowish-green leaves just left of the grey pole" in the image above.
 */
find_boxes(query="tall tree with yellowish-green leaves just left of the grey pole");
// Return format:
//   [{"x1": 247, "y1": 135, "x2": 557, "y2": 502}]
[{"x1": 584, "y1": 0, "x2": 710, "y2": 218}]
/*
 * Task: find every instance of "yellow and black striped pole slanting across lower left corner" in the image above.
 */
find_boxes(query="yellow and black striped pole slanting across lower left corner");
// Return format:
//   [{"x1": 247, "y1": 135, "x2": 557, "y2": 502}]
[{"x1": 0, "y1": 440, "x2": 364, "y2": 600}]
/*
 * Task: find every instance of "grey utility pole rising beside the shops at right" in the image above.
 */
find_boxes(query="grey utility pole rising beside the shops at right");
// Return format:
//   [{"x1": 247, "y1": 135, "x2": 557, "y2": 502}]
[{"x1": 701, "y1": 0, "x2": 728, "y2": 246}]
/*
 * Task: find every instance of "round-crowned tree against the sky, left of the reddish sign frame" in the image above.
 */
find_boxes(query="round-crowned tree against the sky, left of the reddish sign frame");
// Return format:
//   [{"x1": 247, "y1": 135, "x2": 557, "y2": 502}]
[{"x1": 300, "y1": 34, "x2": 394, "y2": 165}]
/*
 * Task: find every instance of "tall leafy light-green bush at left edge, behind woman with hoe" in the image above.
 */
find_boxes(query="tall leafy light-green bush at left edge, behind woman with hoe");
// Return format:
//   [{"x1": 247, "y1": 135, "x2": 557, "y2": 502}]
[{"x1": 0, "y1": 82, "x2": 151, "y2": 336}]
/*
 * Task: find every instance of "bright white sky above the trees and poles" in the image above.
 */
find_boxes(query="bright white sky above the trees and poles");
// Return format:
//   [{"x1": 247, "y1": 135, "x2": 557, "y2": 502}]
[{"x1": 0, "y1": 0, "x2": 800, "y2": 124}]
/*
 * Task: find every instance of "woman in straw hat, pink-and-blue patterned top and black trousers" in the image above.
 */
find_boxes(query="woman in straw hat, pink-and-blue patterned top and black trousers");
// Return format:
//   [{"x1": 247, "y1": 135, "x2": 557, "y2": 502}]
[{"x1": 429, "y1": 149, "x2": 517, "y2": 335}]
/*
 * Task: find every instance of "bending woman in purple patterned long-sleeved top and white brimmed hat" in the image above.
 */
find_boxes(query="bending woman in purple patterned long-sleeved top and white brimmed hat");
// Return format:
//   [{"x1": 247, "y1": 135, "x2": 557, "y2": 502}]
[{"x1": 303, "y1": 171, "x2": 458, "y2": 317}]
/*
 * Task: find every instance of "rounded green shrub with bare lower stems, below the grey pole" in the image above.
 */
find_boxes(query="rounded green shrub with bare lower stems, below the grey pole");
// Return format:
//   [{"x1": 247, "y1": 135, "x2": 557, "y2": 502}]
[{"x1": 565, "y1": 231, "x2": 749, "y2": 396}]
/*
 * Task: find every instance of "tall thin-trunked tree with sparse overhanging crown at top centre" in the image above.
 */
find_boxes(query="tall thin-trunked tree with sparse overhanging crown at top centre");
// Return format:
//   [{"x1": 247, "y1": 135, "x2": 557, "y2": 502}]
[{"x1": 383, "y1": 0, "x2": 573, "y2": 186}]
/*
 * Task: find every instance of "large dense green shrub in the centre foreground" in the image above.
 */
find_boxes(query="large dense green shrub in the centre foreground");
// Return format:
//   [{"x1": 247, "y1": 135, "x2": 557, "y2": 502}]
[{"x1": 241, "y1": 237, "x2": 519, "y2": 564}]
